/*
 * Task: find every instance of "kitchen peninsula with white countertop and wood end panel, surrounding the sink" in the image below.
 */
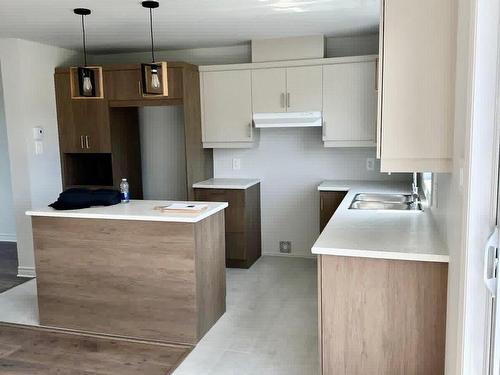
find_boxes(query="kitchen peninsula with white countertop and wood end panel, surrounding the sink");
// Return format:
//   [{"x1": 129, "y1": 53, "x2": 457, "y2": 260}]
[{"x1": 312, "y1": 181, "x2": 449, "y2": 375}]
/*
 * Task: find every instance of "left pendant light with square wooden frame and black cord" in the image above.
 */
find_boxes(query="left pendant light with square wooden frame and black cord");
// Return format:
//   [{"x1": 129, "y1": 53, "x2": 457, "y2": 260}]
[{"x1": 70, "y1": 8, "x2": 104, "y2": 99}]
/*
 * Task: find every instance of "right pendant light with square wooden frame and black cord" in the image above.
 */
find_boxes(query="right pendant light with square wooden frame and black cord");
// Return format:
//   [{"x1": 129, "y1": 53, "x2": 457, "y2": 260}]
[{"x1": 141, "y1": 1, "x2": 168, "y2": 96}]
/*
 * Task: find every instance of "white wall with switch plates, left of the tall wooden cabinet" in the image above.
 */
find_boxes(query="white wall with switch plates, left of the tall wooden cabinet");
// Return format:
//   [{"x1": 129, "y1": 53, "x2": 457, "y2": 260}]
[{"x1": 0, "y1": 39, "x2": 77, "y2": 274}]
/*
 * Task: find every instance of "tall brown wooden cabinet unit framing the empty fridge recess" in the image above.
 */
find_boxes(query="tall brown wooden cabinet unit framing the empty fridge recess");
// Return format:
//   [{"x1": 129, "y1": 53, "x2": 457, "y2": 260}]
[{"x1": 54, "y1": 63, "x2": 213, "y2": 200}]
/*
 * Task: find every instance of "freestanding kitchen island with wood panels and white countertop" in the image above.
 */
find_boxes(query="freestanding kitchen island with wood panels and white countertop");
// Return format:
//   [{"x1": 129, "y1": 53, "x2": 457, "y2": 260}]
[{"x1": 26, "y1": 200, "x2": 228, "y2": 344}]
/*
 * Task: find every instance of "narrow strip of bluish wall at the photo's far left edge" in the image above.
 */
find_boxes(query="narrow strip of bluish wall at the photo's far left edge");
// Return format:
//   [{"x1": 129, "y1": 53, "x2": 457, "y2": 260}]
[{"x1": 0, "y1": 68, "x2": 16, "y2": 241}]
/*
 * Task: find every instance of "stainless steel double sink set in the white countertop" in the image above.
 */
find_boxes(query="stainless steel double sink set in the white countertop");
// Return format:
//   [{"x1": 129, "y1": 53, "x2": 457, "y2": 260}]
[{"x1": 349, "y1": 193, "x2": 423, "y2": 211}]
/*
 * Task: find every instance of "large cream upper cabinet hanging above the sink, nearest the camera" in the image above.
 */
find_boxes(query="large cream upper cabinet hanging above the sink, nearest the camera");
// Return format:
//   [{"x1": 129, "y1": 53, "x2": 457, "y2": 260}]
[{"x1": 377, "y1": 0, "x2": 457, "y2": 172}]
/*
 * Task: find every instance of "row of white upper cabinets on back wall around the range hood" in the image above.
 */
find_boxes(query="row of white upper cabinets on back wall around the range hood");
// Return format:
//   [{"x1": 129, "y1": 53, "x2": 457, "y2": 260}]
[{"x1": 199, "y1": 56, "x2": 377, "y2": 148}]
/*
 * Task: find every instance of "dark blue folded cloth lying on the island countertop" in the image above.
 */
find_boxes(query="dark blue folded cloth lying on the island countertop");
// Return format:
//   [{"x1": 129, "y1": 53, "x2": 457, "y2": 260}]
[{"x1": 49, "y1": 188, "x2": 121, "y2": 210}]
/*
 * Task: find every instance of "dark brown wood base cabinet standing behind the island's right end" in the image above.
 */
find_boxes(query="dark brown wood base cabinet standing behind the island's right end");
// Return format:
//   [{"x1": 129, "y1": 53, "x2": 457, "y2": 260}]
[{"x1": 194, "y1": 184, "x2": 262, "y2": 268}]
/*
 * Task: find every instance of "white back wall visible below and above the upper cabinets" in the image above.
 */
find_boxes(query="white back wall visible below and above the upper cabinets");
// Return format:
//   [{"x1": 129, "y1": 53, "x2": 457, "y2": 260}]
[{"x1": 93, "y1": 34, "x2": 398, "y2": 256}]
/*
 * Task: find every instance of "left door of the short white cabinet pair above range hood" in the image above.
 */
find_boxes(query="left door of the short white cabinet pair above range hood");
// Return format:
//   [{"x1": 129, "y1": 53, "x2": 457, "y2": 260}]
[{"x1": 252, "y1": 68, "x2": 286, "y2": 113}]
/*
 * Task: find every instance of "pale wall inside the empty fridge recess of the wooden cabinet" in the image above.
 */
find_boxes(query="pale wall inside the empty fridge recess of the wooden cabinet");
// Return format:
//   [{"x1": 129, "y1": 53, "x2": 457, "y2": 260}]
[{"x1": 139, "y1": 106, "x2": 187, "y2": 200}]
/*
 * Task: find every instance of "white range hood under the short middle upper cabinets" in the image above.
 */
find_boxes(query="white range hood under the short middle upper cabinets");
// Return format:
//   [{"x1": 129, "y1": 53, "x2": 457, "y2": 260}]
[{"x1": 253, "y1": 112, "x2": 322, "y2": 128}]
